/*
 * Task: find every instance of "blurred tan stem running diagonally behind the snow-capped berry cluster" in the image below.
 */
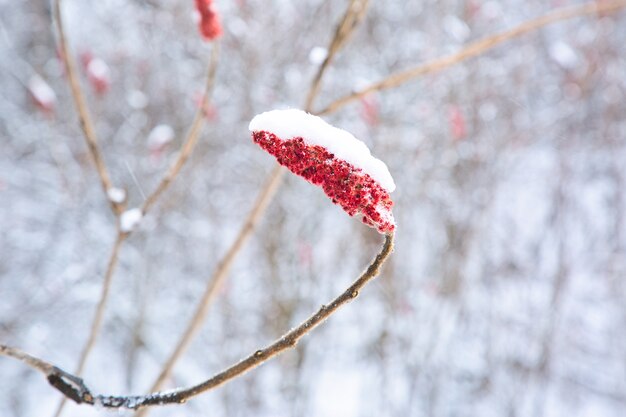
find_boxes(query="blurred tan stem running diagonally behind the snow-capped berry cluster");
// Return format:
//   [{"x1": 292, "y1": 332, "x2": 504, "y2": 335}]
[{"x1": 137, "y1": 0, "x2": 368, "y2": 417}]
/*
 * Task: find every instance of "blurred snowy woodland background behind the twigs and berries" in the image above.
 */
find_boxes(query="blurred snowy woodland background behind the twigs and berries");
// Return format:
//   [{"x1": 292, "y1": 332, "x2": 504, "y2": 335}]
[{"x1": 0, "y1": 0, "x2": 626, "y2": 417}]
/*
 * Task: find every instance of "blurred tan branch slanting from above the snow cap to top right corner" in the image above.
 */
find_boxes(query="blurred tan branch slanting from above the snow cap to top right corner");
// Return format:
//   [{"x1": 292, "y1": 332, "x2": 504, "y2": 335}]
[{"x1": 317, "y1": 0, "x2": 626, "y2": 114}]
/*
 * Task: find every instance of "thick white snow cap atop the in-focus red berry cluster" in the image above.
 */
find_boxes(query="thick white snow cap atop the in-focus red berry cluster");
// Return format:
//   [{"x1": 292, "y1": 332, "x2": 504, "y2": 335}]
[{"x1": 249, "y1": 109, "x2": 396, "y2": 192}]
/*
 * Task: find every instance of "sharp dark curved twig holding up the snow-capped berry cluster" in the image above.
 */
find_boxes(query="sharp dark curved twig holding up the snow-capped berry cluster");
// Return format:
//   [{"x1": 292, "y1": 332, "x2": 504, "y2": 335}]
[{"x1": 0, "y1": 234, "x2": 394, "y2": 409}]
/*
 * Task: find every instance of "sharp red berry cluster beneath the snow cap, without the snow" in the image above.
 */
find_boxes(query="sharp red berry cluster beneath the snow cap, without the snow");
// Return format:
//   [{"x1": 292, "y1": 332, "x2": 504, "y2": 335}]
[{"x1": 252, "y1": 131, "x2": 396, "y2": 233}]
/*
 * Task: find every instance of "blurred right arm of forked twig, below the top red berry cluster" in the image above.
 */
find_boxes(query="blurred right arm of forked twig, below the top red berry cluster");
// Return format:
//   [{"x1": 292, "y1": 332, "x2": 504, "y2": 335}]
[{"x1": 141, "y1": 43, "x2": 219, "y2": 214}]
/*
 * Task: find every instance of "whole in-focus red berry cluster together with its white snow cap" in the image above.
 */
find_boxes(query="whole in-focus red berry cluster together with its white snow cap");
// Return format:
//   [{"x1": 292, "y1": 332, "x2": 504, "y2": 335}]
[{"x1": 250, "y1": 109, "x2": 396, "y2": 233}]
